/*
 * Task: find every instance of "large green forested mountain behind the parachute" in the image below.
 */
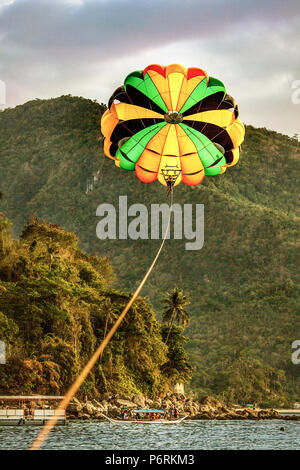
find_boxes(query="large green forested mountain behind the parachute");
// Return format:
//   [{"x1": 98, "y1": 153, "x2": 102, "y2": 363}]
[{"x1": 0, "y1": 96, "x2": 300, "y2": 404}]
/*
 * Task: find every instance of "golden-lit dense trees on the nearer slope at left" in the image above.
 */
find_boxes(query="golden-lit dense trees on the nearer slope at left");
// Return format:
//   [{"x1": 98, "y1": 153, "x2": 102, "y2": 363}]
[{"x1": 0, "y1": 216, "x2": 191, "y2": 396}]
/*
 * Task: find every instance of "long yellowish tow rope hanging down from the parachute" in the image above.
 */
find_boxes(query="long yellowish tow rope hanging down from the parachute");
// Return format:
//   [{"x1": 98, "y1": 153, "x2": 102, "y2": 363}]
[{"x1": 29, "y1": 192, "x2": 173, "y2": 450}]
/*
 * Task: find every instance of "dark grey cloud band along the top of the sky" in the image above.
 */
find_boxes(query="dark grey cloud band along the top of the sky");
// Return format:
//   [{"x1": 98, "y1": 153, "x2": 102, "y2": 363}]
[{"x1": 0, "y1": 0, "x2": 299, "y2": 57}]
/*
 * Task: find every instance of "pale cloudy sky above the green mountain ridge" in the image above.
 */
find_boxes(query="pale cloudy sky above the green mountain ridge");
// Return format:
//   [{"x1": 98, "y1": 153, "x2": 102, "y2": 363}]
[{"x1": 0, "y1": 0, "x2": 300, "y2": 135}]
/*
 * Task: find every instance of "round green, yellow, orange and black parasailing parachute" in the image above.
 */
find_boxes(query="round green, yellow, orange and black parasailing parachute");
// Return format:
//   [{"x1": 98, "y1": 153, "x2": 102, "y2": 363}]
[{"x1": 101, "y1": 64, "x2": 245, "y2": 185}]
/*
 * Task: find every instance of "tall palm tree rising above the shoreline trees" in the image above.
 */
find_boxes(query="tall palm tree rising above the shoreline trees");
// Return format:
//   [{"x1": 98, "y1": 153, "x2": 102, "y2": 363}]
[{"x1": 162, "y1": 287, "x2": 190, "y2": 343}]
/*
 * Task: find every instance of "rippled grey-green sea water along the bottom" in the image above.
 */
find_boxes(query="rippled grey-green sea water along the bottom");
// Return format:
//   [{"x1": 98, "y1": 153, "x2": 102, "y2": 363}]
[{"x1": 0, "y1": 420, "x2": 300, "y2": 450}]
